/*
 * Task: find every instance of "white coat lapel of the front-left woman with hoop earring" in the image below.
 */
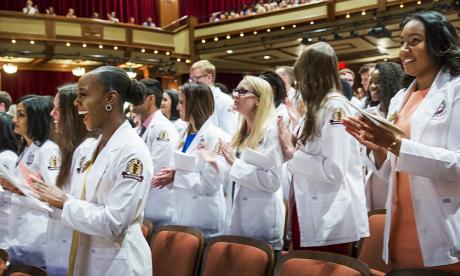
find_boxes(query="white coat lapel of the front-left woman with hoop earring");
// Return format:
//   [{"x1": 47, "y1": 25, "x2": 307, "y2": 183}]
[{"x1": 86, "y1": 121, "x2": 127, "y2": 201}]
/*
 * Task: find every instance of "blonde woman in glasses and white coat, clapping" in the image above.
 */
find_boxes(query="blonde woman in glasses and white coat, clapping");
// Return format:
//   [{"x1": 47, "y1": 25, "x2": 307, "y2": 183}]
[{"x1": 221, "y1": 76, "x2": 285, "y2": 250}]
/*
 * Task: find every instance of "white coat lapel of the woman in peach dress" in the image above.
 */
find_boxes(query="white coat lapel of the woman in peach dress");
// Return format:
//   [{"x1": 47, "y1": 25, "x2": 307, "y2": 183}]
[{"x1": 411, "y1": 70, "x2": 449, "y2": 141}]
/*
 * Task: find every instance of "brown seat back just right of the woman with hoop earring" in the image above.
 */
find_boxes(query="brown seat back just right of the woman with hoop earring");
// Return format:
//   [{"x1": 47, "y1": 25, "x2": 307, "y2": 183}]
[{"x1": 150, "y1": 225, "x2": 203, "y2": 276}]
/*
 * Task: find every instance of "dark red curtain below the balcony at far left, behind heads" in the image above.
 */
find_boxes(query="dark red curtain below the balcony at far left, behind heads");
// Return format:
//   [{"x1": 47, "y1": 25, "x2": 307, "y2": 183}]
[{"x1": 0, "y1": 70, "x2": 78, "y2": 102}]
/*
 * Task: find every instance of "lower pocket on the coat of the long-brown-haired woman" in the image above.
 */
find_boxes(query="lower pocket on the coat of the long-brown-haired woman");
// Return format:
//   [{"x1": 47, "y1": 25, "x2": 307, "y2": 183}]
[{"x1": 311, "y1": 192, "x2": 357, "y2": 242}]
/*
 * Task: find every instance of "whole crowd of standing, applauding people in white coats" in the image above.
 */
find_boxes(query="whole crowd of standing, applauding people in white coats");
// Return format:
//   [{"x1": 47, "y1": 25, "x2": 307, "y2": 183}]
[{"x1": 0, "y1": 11, "x2": 460, "y2": 275}]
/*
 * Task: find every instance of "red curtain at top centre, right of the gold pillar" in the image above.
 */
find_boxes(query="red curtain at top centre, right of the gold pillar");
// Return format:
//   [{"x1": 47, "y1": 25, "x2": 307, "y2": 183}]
[{"x1": 180, "y1": 0, "x2": 256, "y2": 21}]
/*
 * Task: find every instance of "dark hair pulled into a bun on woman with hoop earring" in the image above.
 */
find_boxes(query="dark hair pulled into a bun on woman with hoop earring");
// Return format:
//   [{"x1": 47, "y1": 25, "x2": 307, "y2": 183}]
[{"x1": 91, "y1": 66, "x2": 145, "y2": 106}]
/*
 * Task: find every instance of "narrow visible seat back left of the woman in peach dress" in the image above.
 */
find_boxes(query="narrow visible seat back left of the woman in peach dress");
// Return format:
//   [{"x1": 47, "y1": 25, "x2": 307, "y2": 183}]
[{"x1": 358, "y1": 209, "x2": 391, "y2": 275}]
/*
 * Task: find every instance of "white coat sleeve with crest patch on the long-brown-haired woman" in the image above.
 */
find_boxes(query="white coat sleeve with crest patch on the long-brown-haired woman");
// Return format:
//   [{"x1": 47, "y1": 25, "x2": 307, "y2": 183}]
[{"x1": 288, "y1": 101, "x2": 359, "y2": 184}]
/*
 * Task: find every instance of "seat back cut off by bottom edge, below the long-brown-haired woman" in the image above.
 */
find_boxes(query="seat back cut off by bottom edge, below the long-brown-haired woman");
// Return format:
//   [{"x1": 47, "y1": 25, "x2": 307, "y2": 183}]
[{"x1": 274, "y1": 250, "x2": 370, "y2": 276}]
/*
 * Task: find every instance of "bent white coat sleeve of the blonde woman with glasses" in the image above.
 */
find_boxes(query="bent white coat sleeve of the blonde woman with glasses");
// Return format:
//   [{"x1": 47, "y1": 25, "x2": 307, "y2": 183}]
[{"x1": 230, "y1": 128, "x2": 283, "y2": 193}]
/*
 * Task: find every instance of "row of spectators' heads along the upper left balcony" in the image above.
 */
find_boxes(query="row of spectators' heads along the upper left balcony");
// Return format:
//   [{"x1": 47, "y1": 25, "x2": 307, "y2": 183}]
[{"x1": 22, "y1": 0, "x2": 156, "y2": 28}]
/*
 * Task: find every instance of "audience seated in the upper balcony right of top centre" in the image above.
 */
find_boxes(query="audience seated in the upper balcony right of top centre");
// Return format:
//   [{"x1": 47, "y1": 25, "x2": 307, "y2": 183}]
[{"x1": 209, "y1": 0, "x2": 321, "y2": 22}]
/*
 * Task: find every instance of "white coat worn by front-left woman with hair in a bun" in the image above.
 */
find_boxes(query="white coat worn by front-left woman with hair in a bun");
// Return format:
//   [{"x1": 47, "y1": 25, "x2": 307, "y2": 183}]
[{"x1": 60, "y1": 121, "x2": 153, "y2": 276}]
